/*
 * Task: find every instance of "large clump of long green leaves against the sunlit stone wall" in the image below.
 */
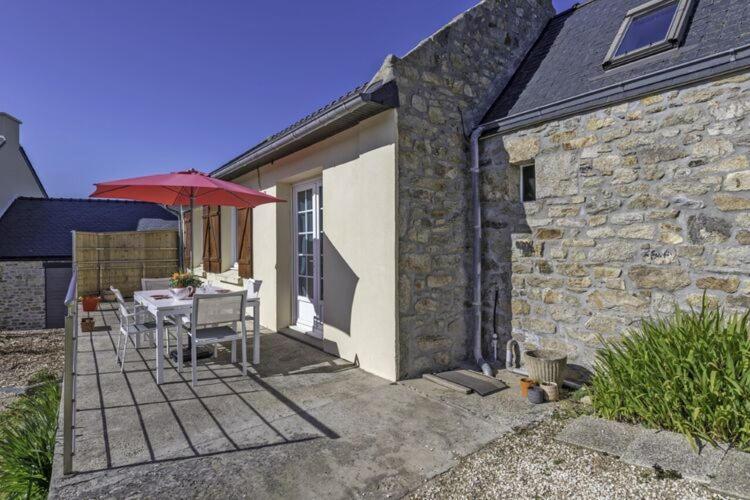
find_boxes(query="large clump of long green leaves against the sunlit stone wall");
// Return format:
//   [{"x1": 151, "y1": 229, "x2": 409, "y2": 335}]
[{"x1": 592, "y1": 301, "x2": 750, "y2": 451}]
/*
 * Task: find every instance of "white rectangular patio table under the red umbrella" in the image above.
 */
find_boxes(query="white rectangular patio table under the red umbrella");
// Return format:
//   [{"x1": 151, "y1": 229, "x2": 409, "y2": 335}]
[{"x1": 133, "y1": 289, "x2": 260, "y2": 384}]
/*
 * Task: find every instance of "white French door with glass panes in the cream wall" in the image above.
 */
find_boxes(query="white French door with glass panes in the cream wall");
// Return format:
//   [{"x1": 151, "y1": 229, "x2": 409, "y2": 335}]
[{"x1": 292, "y1": 180, "x2": 323, "y2": 338}]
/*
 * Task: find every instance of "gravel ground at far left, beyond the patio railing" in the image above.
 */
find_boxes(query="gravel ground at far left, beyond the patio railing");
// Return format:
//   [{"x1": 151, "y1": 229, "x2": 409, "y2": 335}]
[{"x1": 0, "y1": 329, "x2": 65, "y2": 410}]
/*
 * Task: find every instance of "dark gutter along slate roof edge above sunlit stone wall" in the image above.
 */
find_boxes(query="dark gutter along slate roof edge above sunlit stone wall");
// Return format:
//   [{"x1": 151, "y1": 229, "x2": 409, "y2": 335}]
[{"x1": 482, "y1": 44, "x2": 750, "y2": 138}]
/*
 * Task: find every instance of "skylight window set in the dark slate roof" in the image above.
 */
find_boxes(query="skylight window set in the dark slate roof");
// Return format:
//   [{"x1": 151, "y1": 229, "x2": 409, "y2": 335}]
[{"x1": 604, "y1": 0, "x2": 694, "y2": 67}]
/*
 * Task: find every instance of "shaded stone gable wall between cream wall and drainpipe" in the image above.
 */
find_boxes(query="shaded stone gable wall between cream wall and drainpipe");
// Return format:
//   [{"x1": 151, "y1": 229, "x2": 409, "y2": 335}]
[{"x1": 390, "y1": 0, "x2": 554, "y2": 378}]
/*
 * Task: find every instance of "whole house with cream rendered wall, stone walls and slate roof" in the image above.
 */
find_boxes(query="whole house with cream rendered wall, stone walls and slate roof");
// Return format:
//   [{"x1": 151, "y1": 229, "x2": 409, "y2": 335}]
[{"x1": 198, "y1": 0, "x2": 750, "y2": 379}]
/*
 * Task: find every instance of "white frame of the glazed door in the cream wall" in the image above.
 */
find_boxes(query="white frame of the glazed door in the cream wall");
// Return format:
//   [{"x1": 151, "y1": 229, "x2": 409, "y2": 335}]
[{"x1": 291, "y1": 178, "x2": 323, "y2": 338}]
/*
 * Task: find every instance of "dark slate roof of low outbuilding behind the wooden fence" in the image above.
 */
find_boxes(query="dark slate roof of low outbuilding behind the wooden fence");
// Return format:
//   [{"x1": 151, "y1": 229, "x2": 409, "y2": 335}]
[{"x1": 0, "y1": 197, "x2": 176, "y2": 260}]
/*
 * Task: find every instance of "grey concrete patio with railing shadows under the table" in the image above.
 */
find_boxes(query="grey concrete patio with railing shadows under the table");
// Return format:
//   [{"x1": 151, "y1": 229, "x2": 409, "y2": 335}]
[{"x1": 50, "y1": 304, "x2": 552, "y2": 498}]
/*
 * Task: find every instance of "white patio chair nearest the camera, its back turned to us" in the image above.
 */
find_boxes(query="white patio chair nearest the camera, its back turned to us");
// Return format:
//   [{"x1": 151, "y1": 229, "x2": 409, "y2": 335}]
[{"x1": 182, "y1": 291, "x2": 247, "y2": 386}]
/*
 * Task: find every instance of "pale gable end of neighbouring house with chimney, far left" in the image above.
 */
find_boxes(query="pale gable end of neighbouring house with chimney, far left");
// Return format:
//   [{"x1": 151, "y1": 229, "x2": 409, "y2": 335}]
[{"x1": 0, "y1": 112, "x2": 47, "y2": 215}]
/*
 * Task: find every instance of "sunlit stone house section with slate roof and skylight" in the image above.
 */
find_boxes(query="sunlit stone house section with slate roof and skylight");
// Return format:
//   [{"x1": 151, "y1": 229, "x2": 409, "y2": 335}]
[{"x1": 480, "y1": 0, "x2": 750, "y2": 367}]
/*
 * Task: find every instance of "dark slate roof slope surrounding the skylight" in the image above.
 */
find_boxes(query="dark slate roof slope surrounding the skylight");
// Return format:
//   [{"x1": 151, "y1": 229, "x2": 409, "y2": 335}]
[{"x1": 484, "y1": 0, "x2": 750, "y2": 122}]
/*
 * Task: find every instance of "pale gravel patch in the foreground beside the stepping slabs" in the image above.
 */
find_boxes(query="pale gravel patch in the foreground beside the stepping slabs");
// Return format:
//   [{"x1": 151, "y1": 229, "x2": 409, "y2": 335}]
[{"x1": 408, "y1": 403, "x2": 725, "y2": 499}]
